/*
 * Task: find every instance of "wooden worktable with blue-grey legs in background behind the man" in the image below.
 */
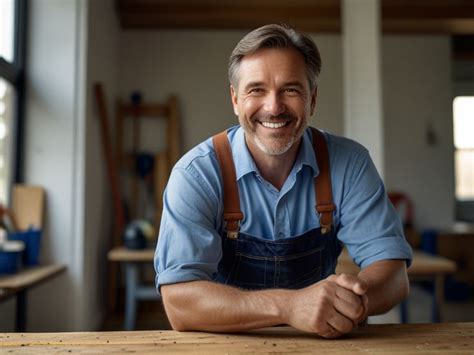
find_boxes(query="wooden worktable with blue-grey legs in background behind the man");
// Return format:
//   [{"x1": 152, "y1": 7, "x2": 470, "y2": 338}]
[{"x1": 108, "y1": 247, "x2": 456, "y2": 330}]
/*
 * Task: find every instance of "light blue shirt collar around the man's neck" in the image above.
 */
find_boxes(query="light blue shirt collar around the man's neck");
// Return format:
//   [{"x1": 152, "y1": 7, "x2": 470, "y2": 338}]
[{"x1": 231, "y1": 127, "x2": 319, "y2": 180}]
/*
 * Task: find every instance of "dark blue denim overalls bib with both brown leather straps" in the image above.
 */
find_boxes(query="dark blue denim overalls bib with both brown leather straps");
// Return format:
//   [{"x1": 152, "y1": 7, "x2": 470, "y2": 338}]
[{"x1": 213, "y1": 128, "x2": 341, "y2": 290}]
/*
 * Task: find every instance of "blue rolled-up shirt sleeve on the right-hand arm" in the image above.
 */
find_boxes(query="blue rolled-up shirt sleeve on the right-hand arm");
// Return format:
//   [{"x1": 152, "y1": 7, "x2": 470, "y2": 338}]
[{"x1": 338, "y1": 149, "x2": 412, "y2": 268}]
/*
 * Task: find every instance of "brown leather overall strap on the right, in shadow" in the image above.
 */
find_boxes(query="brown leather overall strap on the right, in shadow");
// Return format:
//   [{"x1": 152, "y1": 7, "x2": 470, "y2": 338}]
[{"x1": 311, "y1": 127, "x2": 336, "y2": 234}]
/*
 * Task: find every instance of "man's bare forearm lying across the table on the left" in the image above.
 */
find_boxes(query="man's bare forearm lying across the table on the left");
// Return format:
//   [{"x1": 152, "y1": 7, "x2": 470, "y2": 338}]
[{"x1": 161, "y1": 281, "x2": 292, "y2": 332}]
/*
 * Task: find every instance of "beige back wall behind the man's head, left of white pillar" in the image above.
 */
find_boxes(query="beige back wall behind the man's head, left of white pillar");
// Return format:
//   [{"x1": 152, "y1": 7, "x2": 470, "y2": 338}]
[{"x1": 120, "y1": 31, "x2": 343, "y2": 151}]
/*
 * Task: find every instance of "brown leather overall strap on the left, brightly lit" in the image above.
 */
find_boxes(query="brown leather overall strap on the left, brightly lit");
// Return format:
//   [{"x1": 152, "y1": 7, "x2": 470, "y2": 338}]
[{"x1": 212, "y1": 131, "x2": 244, "y2": 239}]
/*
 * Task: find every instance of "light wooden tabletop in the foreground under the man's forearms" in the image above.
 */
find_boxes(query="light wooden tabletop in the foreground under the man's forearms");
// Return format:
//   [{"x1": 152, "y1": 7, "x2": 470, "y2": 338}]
[{"x1": 0, "y1": 323, "x2": 474, "y2": 355}]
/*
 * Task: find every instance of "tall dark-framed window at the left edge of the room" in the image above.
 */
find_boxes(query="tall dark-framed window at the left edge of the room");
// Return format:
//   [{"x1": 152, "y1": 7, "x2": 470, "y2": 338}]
[{"x1": 0, "y1": 0, "x2": 27, "y2": 204}]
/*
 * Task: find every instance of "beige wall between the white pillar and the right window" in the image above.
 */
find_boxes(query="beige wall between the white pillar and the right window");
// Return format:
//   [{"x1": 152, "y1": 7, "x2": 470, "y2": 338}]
[{"x1": 383, "y1": 36, "x2": 454, "y2": 228}]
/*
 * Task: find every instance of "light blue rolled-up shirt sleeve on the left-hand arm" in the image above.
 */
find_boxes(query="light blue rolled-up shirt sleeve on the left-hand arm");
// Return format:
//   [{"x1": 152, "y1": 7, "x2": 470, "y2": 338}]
[{"x1": 154, "y1": 166, "x2": 222, "y2": 293}]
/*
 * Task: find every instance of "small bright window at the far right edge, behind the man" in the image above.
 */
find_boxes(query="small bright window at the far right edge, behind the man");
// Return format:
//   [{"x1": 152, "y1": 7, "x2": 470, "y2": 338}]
[{"x1": 453, "y1": 96, "x2": 474, "y2": 202}]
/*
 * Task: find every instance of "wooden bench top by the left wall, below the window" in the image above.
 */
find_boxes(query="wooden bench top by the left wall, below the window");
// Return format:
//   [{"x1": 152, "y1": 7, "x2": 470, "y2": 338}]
[{"x1": 0, "y1": 265, "x2": 66, "y2": 300}]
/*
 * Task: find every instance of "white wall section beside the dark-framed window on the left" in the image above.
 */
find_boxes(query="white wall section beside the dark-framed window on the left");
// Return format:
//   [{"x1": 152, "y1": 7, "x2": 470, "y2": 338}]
[{"x1": 12, "y1": 0, "x2": 86, "y2": 331}]
